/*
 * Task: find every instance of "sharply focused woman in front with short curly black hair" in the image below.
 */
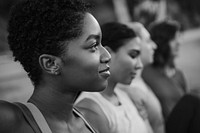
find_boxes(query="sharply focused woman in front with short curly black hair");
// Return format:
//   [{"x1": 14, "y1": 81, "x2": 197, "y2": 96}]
[{"x1": 0, "y1": 0, "x2": 111, "y2": 133}]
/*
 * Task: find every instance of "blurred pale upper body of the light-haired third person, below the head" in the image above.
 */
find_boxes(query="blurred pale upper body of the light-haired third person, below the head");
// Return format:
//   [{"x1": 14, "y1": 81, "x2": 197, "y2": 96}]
[{"x1": 118, "y1": 76, "x2": 165, "y2": 133}]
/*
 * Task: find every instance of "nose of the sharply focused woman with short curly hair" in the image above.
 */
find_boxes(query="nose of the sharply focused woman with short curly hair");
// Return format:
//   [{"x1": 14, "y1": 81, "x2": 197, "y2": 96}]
[{"x1": 100, "y1": 46, "x2": 111, "y2": 63}]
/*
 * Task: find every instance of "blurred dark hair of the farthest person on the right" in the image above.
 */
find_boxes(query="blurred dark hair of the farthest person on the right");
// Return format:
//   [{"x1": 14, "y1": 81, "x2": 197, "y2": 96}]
[{"x1": 149, "y1": 20, "x2": 180, "y2": 67}]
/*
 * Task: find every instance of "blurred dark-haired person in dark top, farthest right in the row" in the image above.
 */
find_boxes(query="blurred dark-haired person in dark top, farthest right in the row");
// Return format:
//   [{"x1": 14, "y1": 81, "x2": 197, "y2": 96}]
[{"x1": 142, "y1": 20, "x2": 187, "y2": 120}]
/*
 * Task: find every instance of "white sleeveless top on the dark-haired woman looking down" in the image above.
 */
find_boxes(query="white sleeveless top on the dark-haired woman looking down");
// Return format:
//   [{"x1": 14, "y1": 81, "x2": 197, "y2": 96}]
[{"x1": 75, "y1": 88, "x2": 148, "y2": 133}]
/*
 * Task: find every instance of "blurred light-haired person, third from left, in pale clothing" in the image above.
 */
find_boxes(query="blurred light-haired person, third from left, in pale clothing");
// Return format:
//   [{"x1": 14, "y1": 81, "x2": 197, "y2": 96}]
[{"x1": 118, "y1": 22, "x2": 165, "y2": 133}]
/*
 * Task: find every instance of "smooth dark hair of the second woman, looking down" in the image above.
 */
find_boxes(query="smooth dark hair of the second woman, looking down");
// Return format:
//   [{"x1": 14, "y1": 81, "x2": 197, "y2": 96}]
[{"x1": 101, "y1": 22, "x2": 136, "y2": 52}]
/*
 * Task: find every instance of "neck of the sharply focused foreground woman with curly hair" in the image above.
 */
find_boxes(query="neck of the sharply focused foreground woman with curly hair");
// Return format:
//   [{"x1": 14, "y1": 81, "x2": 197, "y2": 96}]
[{"x1": 29, "y1": 84, "x2": 77, "y2": 122}]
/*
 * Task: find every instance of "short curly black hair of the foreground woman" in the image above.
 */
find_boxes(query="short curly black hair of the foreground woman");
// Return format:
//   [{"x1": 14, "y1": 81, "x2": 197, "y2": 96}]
[{"x1": 8, "y1": 0, "x2": 90, "y2": 86}]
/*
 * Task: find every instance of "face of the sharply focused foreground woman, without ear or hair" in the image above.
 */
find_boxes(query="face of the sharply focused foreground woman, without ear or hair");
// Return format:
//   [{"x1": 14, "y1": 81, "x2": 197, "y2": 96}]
[{"x1": 61, "y1": 13, "x2": 111, "y2": 91}]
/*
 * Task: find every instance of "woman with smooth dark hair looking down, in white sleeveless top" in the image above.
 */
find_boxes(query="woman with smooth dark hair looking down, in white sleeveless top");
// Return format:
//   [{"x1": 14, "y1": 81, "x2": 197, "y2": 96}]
[{"x1": 77, "y1": 22, "x2": 152, "y2": 133}]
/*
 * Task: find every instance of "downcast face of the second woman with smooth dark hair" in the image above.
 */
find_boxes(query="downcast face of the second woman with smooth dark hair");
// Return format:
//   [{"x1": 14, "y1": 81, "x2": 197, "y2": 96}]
[{"x1": 110, "y1": 37, "x2": 142, "y2": 84}]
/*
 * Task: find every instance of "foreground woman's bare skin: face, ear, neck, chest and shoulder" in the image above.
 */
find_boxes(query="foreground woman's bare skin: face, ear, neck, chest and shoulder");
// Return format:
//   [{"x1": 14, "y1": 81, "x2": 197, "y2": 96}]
[{"x1": 0, "y1": 13, "x2": 111, "y2": 133}]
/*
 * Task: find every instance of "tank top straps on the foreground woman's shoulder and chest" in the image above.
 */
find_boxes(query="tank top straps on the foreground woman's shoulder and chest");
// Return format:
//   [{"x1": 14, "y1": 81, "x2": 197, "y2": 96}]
[{"x1": 15, "y1": 103, "x2": 96, "y2": 133}]
